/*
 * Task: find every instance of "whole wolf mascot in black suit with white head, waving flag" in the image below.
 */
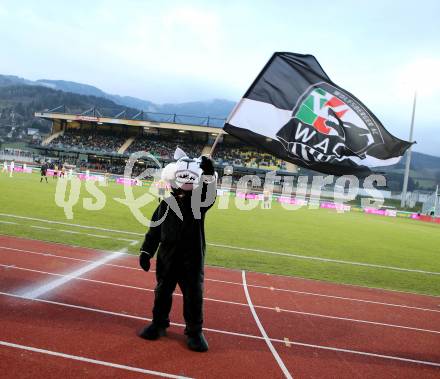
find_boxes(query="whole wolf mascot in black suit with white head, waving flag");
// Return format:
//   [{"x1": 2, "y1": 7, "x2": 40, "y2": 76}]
[{"x1": 139, "y1": 148, "x2": 217, "y2": 352}]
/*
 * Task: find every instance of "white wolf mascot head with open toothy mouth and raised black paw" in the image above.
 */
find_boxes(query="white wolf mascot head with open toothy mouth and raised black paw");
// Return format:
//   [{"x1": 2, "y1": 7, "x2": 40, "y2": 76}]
[{"x1": 161, "y1": 147, "x2": 217, "y2": 193}]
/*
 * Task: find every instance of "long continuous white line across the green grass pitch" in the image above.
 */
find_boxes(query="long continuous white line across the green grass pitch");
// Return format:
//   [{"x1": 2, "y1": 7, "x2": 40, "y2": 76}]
[{"x1": 0, "y1": 213, "x2": 440, "y2": 275}]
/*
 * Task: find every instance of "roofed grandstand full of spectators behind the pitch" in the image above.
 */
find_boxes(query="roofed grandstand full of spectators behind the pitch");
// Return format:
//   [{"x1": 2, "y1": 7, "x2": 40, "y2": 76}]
[{"x1": 33, "y1": 106, "x2": 296, "y2": 176}]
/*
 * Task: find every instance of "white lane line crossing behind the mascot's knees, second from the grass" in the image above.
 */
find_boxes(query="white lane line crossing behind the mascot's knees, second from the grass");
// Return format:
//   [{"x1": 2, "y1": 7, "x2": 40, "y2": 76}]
[{"x1": 0, "y1": 264, "x2": 440, "y2": 334}]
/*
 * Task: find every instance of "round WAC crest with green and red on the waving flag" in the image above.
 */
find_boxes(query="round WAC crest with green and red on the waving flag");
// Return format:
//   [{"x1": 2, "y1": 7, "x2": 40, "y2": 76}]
[{"x1": 277, "y1": 82, "x2": 383, "y2": 163}]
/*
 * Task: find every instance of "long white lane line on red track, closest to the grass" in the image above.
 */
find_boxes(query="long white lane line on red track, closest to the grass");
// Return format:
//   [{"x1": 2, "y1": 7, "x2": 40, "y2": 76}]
[{"x1": 0, "y1": 246, "x2": 440, "y2": 313}]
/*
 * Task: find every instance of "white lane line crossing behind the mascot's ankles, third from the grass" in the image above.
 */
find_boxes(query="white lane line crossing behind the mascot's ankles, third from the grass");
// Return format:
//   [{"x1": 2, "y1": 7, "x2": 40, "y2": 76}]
[{"x1": 0, "y1": 292, "x2": 440, "y2": 367}]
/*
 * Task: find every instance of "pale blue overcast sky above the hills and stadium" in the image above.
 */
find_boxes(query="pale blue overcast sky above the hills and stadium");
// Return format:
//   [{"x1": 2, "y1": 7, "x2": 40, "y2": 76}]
[{"x1": 0, "y1": 0, "x2": 440, "y2": 156}]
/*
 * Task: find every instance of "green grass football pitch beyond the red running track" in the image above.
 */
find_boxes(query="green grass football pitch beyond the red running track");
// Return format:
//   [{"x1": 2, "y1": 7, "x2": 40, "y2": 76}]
[{"x1": 0, "y1": 174, "x2": 440, "y2": 295}]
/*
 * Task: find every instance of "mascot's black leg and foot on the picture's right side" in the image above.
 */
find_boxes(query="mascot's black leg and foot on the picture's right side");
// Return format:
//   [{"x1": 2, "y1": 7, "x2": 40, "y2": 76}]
[{"x1": 179, "y1": 276, "x2": 208, "y2": 352}]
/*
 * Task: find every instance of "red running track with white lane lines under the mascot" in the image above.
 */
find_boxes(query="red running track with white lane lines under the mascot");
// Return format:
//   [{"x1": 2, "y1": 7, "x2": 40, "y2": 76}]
[{"x1": 0, "y1": 236, "x2": 440, "y2": 378}]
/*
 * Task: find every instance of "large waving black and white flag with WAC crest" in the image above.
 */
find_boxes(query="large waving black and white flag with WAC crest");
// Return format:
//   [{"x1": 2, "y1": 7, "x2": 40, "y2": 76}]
[{"x1": 224, "y1": 53, "x2": 411, "y2": 176}]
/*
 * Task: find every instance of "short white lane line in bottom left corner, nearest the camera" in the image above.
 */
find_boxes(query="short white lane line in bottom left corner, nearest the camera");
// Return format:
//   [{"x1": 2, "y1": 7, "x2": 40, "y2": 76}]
[{"x1": 0, "y1": 341, "x2": 189, "y2": 379}]
